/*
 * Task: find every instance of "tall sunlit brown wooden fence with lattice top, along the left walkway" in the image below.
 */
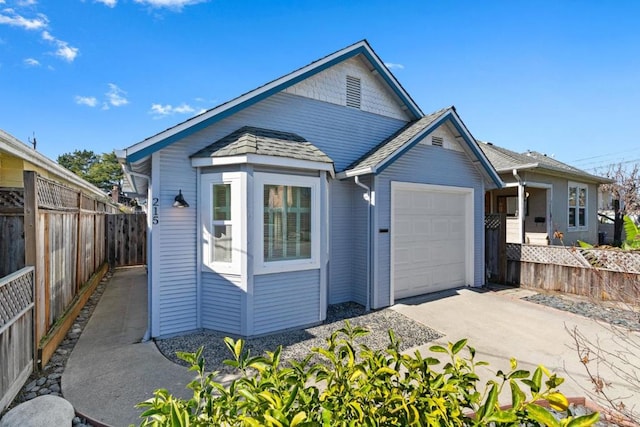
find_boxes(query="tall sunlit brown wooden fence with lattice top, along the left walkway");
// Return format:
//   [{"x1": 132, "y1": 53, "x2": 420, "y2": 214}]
[{"x1": 24, "y1": 171, "x2": 117, "y2": 366}]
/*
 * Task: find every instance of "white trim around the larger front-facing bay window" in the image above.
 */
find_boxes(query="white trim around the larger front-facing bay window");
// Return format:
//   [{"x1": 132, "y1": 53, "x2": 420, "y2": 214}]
[{"x1": 253, "y1": 172, "x2": 321, "y2": 274}]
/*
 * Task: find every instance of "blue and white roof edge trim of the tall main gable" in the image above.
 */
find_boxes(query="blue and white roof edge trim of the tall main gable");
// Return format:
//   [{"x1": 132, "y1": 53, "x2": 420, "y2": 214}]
[{"x1": 118, "y1": 40, "x2": 423, "y2": 163}]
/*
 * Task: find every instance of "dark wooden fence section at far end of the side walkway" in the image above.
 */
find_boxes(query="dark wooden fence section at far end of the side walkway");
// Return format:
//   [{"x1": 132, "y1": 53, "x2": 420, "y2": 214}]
[{"x1": 107, "y1": 213, "x2": 147, "y2": 267}]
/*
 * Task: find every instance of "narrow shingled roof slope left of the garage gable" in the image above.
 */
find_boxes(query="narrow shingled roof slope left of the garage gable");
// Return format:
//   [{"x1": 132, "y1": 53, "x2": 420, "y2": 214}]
[{"x1": 345, "y1": 107, "x2": 453, "y2": 171}]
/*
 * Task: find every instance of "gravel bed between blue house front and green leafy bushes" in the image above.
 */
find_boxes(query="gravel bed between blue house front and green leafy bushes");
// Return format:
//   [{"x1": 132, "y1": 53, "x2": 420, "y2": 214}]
[{"x1": 156, "y1": 303, "x2": 442, "y2": 373}]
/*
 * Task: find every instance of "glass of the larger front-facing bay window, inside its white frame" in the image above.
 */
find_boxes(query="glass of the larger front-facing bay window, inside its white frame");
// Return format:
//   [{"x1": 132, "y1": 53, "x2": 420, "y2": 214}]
[{"x1": 263, "y1": 185, "x2": 311, "y2": 261}]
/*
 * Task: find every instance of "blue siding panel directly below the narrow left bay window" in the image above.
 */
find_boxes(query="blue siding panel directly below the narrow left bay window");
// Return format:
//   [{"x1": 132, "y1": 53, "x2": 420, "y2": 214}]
[{"x1": 201, "y1": 272, "x2": 245, "y2": 335}]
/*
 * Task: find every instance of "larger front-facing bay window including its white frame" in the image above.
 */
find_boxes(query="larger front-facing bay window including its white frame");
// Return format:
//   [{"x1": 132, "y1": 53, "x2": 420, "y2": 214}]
[{"x1": 254, "y1": 173, "x2": 320, "y2": 274}]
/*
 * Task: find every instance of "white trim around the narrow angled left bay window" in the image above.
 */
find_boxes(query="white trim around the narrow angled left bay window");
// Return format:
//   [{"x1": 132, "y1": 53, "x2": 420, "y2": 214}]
[{"x1": 201, "y1": 172, "x2": 246, "y2": 274}]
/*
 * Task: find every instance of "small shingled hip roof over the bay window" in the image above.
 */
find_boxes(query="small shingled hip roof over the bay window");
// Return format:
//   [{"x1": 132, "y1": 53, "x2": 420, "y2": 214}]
[{"x1": 190, "y1": 126, "x2": 333, "y2": 175}]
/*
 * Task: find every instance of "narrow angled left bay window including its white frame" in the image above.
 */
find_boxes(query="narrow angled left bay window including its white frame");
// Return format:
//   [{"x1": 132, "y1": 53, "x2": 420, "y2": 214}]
[{"x1": 201, "y1": 172, "x2": 243, "y2": 273}]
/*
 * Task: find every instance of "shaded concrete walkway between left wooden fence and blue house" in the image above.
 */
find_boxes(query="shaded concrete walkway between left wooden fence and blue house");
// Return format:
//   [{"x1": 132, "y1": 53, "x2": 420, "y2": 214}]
[{"x1": 62, "y1": 267, "x2": 193, "y2": 427}]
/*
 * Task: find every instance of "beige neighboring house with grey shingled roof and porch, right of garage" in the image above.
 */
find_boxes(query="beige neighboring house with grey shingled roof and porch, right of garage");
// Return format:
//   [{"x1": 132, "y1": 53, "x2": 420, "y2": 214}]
[{"x1": 480, "y1": 142, "x2": 613, "y2": 245}]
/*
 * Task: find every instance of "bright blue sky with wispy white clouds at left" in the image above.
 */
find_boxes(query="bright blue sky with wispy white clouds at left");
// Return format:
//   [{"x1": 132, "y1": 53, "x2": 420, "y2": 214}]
[{"x1": 0, "y1": 0, "x2": 640, "y2": 170}]
